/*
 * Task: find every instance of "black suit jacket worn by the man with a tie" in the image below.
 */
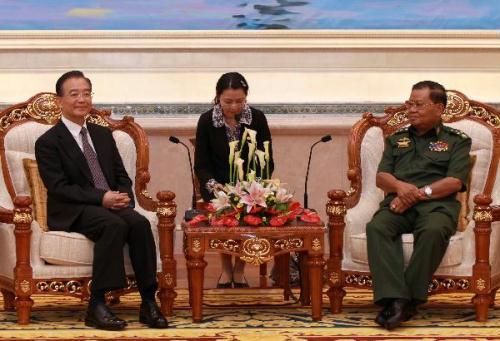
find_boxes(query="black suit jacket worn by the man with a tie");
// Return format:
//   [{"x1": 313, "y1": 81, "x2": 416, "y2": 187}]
[{"x1": 35, "y1": 122, "x2": 134, "y2": 231}]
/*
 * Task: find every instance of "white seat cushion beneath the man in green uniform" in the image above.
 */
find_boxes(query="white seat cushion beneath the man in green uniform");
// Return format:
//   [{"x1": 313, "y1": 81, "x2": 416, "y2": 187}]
[{"x1": 350, "y1": 232, "x2": 463, "y2": 267}]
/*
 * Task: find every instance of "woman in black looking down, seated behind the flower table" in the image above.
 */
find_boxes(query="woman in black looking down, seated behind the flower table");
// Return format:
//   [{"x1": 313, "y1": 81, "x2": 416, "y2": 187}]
[{"x1": 194, "y1": 72, "x2": 274, "y2": 288}]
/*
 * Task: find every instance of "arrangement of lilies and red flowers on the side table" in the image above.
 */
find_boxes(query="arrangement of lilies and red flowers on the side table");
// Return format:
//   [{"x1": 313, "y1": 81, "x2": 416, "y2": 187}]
[{"x1": 189, "y1": 128, "x2": 320, "y2": 227}]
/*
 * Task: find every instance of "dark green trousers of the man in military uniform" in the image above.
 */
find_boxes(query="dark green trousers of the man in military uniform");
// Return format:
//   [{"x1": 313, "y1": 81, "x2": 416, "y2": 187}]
[{"x1": 366, "y1": 207, "x2": 456, "y2": 304}]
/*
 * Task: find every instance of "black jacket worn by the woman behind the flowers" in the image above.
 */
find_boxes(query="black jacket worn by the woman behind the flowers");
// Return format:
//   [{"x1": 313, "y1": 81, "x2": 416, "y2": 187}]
[{"x1": 194, "y1": 108, "x2": 274, "y2": 201}]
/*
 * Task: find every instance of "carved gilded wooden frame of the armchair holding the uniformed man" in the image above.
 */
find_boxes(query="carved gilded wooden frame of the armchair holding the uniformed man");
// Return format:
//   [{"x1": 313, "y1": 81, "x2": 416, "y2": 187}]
[{"x1": 326, "y1": 91, "x2": 500, "y2": 321}]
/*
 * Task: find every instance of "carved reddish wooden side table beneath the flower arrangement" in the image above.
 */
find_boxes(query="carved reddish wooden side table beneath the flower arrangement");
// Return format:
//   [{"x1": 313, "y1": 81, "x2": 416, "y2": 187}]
[{"x1": 182, "y1": 222, "x2": 326, "y2": 322}]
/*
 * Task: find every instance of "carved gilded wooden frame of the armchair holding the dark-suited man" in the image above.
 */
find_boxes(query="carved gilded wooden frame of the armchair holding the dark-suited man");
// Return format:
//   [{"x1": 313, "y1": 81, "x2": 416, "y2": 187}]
[{"x1": 0, "y1": 93, "x2": 176, "y2": 324}]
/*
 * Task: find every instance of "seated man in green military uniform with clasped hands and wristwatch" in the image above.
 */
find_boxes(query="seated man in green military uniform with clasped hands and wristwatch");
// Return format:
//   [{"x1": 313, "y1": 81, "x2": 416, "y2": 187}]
[{"x1": 366, "y1": 81, "x2": 471, "y2": 330}]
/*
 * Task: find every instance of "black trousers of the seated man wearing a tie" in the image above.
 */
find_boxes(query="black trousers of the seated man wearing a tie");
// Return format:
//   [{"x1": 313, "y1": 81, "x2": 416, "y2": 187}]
[{"x1": 71, "y1": 206, "x2": 156, "y2": 293}]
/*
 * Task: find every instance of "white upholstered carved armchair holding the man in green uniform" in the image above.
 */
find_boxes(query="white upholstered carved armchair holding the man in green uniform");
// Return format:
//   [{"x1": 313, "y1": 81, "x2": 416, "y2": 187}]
[{"x1": 327, "y1": 91, "x2": 500, "y2": 321}]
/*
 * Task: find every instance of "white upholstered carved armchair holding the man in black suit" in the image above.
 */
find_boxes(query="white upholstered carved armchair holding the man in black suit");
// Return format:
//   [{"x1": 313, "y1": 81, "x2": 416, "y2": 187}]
[{"x1": 0, "y1": 93, "x2": 176, "y2": 324}]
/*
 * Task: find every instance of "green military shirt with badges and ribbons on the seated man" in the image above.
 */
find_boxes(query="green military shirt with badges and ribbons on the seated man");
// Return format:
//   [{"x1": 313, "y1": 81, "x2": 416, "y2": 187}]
[{"x1": 378, "y1": 123, "x2": 471, "y2": 221}]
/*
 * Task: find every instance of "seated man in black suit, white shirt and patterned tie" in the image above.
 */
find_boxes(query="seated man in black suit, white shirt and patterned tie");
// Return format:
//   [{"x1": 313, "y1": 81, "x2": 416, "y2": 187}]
[{"x1": 35, "y1": 71, "x2": 167, "y2": 330}]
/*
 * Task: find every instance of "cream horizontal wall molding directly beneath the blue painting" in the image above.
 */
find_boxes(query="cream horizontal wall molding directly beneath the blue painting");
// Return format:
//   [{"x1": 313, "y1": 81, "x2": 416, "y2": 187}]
[{"x1": 0, "y1": 30, "x2": 500, "y2": 50}]
